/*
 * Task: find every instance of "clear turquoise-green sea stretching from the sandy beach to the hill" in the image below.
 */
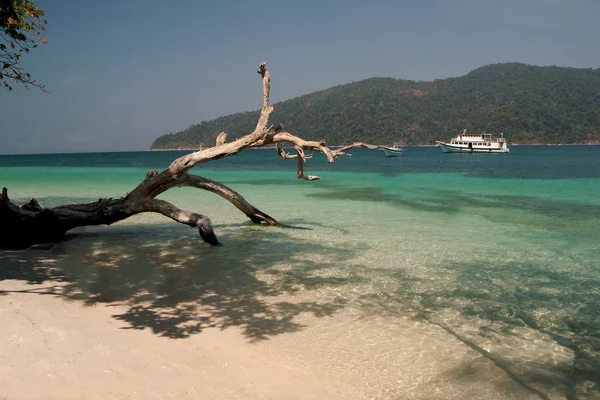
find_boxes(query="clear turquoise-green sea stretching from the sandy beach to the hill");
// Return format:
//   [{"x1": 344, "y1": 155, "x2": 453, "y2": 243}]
[{"x1": 0, "y1": 146, "x2": 600, "y2": 399}]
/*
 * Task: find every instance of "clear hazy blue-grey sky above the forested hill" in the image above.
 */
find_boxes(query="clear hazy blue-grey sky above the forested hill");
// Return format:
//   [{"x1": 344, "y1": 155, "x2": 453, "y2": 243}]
[{"x1": 0, "y1": 0, "x2": 600, "y2": 154}]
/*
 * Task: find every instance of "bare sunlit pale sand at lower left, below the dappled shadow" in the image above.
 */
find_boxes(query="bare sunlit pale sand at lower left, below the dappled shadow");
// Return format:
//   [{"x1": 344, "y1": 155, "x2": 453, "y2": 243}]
[{"x1": 0, "y1": 281, "x2": 345, "y2": 399}]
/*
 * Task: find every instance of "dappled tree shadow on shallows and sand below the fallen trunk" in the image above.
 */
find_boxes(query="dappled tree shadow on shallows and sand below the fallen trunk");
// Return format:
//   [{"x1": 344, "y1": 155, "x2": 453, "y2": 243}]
[{"x1": 0, "y1": 226, "x2": 363, "y2": 341}]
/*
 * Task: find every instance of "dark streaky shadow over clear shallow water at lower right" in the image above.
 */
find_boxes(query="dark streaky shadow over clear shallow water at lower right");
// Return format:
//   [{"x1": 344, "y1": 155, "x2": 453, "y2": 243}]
[{"x1": 361, "y1": 263, "x2": 600, "y2": 400}]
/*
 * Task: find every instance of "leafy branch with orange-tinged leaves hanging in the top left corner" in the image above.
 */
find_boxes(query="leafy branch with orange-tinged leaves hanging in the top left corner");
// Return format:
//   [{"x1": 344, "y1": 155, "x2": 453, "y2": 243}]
[{"x1": 0, "y1": 0, "x2": 47, "y2": 90}]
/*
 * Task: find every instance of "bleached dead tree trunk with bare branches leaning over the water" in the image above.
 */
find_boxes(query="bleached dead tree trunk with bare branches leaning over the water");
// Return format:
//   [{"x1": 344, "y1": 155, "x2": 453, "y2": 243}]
[{"x1": 0, "y1": 62, "x2": 377, "y2": 248}]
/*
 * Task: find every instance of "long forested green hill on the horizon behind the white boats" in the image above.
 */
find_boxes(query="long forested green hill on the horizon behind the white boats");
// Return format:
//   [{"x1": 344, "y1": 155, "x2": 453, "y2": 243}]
[{"x1": 151, "y1": 63, "x2": 600, "y2": 149}]
